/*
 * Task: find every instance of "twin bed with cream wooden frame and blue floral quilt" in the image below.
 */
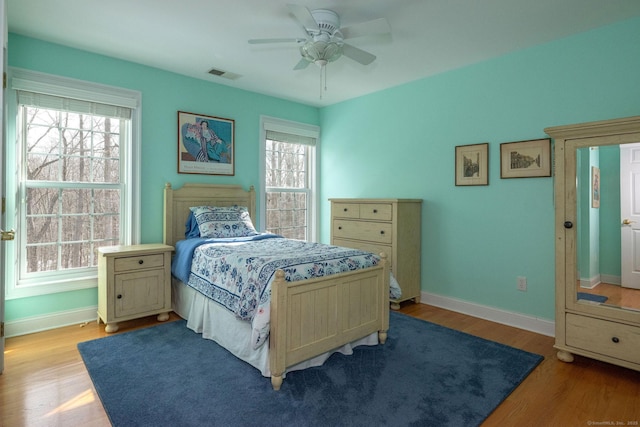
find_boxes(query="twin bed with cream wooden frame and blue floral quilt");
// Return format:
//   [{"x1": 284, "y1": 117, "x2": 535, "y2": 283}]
[{"x1": 164, "y1": 184, "x2": 390, "y2": 390}]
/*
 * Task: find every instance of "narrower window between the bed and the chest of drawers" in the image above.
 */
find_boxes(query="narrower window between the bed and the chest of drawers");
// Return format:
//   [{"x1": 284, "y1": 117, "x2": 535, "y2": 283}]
[{"x1": 261, "y1": 119, "x2": 318, "y2": 241}]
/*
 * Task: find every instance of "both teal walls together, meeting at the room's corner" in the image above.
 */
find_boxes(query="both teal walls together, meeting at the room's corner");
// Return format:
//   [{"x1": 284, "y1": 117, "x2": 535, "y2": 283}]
[{"x1": 6, "y1": 15, "x2": 640, "y2": 321}]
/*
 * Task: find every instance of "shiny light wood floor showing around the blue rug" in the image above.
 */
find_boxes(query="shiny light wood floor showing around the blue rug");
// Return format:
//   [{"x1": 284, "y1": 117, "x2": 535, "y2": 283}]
[{"x1": 0, "y1": 303, "x2": 640, "y2": 427}]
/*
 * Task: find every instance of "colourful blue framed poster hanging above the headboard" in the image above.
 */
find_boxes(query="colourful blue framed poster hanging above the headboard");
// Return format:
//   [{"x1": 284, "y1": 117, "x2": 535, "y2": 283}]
[{"x1": 178, "y1": 111, "x2": 235, "y2": 175}]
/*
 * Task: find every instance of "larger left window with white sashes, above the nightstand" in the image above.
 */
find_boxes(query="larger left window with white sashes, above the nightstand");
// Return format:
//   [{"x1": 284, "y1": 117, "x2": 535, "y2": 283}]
[{"x1": 8, "y1": 73, "x2": 139, "y2": 295}]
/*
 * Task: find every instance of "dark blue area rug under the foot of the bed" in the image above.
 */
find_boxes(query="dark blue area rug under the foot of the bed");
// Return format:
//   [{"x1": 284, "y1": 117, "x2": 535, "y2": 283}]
[{"x1": 78, "y1": 312, "x2": 543, "y2": 427}]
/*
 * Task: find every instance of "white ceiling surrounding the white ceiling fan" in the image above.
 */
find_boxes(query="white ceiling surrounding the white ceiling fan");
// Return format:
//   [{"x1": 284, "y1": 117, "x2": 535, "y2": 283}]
[{"x1": 7, "y1": 0, "x2": 640, "y2": 106}]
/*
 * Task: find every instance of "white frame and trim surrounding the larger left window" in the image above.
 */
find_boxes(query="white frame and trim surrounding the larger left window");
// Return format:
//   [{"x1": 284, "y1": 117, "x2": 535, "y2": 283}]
[{"x1": 5, "y1": 68, "x2": 142, "y2": 300}]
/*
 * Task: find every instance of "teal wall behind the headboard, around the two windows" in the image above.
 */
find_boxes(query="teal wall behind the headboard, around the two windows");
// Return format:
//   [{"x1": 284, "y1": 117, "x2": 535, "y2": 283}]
[{"x1": 5, "y1": 34, "x2": 319, "y2": 322}]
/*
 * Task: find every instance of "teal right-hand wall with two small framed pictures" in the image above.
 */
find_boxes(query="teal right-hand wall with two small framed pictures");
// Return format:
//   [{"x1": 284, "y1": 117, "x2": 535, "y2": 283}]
[{"x1": 321, "y1": 19, "x2": 640, "y2": 319}]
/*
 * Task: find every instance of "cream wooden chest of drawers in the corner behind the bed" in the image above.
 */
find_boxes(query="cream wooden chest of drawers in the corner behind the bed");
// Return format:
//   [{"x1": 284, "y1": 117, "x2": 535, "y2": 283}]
[{"x1": 329, "y1": 199, "x2": 422, "y2": 308}]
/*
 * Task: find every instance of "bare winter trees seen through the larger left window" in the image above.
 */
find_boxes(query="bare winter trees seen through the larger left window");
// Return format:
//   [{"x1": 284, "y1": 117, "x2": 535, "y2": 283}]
[{"x1": 22, "y1": 106, "x2": 122, "y2": 274}]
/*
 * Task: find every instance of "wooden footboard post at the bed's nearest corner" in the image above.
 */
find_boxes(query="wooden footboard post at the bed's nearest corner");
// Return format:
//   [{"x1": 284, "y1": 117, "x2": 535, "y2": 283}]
[{"x1": 269, "y1": 270, "x2": 288, "y2": 390}]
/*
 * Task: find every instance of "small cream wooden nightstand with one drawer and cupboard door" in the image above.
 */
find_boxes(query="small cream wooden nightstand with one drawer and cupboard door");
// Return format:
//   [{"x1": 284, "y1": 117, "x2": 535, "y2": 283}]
[{"x1": 98, "y1": 244, "x2": 173, "y2": 333}]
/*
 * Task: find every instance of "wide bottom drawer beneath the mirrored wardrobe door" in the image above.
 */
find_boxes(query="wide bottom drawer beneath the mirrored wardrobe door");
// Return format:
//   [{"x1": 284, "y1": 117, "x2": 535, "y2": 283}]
[{"x1": 566, "y1": 313, "x2": 640, "y2": 363}]
